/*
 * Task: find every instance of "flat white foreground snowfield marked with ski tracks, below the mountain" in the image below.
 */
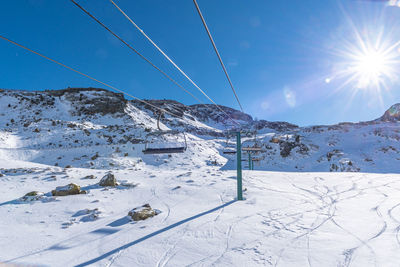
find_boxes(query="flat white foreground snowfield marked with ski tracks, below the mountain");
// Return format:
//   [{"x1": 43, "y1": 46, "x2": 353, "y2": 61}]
[{"x1": 0, "y1": 162, "x2": 400, "y2": 266}]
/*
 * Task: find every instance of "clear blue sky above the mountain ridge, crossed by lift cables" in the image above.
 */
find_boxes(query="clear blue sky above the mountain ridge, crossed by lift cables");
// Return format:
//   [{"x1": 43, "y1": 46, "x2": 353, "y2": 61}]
[{"x1": 0, "y1": 0, "x2": 400, "y2": 125}]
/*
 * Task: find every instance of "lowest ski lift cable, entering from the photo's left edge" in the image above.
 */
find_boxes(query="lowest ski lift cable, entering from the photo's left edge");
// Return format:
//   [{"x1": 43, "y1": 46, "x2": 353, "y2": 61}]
[{"x1": 0, "y1": 35, "x2": 181, "y2": 118}]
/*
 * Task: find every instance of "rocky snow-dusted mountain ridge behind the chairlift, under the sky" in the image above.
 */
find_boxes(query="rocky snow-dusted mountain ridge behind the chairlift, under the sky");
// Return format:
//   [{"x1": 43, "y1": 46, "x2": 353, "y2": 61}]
[{"x1": 0, "y1": 88, "x2": 400, "y2": 173}]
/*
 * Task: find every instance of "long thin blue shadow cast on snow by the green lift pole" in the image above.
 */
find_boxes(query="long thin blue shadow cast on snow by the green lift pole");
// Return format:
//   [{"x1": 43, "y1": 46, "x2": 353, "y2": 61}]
[{"x1": 75, "y1": 199, "x2": 237, "y2": 267}]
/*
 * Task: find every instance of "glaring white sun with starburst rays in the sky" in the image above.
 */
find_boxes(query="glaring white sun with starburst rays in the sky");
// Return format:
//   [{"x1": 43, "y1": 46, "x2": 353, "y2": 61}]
[{"x1": 324, "y1": 12, "x2": 400, "y2": 100}]
